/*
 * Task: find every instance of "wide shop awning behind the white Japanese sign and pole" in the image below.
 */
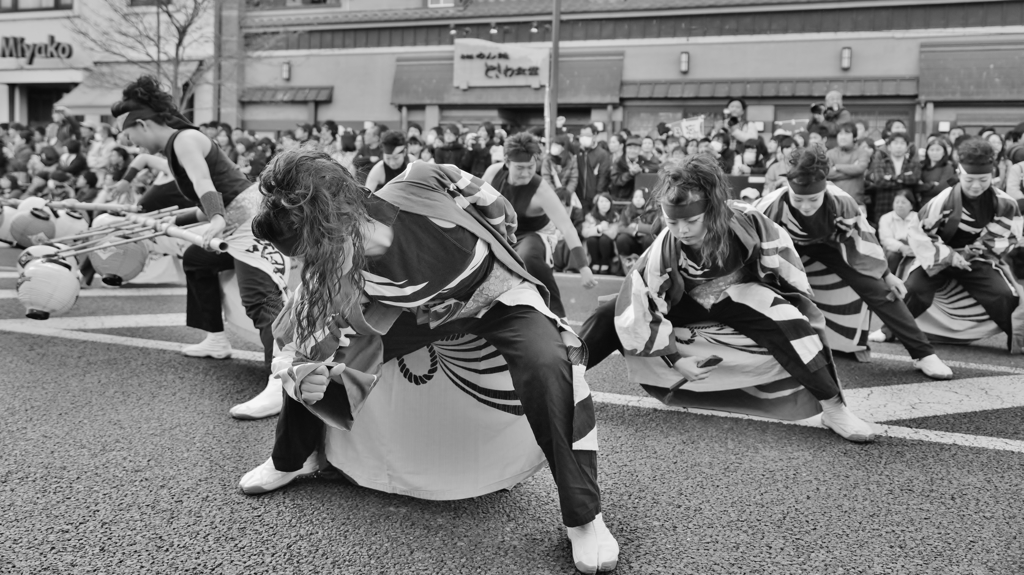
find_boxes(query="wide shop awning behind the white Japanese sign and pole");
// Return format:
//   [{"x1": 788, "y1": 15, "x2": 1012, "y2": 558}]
[{"x1": 391, "y1": 54, "x2": 623, "y2": 106}]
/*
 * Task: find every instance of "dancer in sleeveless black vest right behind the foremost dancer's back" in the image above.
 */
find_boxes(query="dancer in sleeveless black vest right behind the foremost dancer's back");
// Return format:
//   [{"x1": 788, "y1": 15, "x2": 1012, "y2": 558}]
[{"x1": 482, "y1": 132, "x2": 597, "y2": 317}]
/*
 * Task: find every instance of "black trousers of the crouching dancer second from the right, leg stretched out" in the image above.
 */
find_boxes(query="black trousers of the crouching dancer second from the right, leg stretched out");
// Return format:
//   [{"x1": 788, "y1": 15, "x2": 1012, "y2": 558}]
[{"x1": 797, "y1": 245, "x2": 935, "y2": 359}]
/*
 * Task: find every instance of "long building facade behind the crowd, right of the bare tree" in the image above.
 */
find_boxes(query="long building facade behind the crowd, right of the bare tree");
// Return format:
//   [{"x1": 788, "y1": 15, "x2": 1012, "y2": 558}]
[{"x1": 228, "y1": 0, "x2": 1024, "y2": 141}]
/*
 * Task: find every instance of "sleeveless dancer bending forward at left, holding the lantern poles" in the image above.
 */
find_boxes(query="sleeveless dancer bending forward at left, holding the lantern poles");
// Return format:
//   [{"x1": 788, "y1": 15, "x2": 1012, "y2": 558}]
[{"x1": 111, "y1": 76, "x2": 289, "y2": 419}]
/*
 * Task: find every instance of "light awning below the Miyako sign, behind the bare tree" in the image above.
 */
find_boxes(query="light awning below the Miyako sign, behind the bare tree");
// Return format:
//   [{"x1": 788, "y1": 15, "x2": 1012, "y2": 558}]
[{"x1": 56, "y1": 60, "x2": 200, "y2": 116}]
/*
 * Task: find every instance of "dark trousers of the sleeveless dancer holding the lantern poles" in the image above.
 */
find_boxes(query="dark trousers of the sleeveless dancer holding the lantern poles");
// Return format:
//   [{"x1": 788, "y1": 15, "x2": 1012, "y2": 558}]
[{"x1": 182, "y1": 246, "x2": 284, "y2": 366}]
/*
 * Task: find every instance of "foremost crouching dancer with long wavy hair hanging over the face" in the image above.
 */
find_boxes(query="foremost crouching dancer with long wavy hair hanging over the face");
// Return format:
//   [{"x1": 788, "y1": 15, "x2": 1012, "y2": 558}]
[{"x1": 240, "y1": 150, "x2": 618, "y2": 573}]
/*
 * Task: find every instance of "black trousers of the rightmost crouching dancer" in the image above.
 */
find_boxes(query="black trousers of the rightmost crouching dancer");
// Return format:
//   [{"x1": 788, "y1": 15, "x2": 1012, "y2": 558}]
[{"x1": 906, "y1": 262, "x2": 1021, "y2": 336}]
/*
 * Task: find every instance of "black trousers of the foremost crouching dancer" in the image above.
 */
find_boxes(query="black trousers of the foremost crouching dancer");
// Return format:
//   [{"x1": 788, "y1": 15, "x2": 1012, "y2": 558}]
[{"x1": 272, "y1": 304, "x2": 601, "y2": 527}]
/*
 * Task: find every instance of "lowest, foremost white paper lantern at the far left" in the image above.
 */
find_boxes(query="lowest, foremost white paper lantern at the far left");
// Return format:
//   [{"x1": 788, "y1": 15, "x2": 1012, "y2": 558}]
[{"x1": 17, "y1": 257, "x2": 81, "y2": 319}]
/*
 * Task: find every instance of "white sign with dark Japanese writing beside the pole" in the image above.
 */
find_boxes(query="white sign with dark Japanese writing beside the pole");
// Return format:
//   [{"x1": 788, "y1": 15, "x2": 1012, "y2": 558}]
[{"x1": 454, "y1": 39, "x2": 550, "y2": 90}]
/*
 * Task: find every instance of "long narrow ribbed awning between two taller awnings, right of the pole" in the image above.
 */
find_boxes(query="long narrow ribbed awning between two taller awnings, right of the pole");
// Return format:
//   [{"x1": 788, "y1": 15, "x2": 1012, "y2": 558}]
[{"x1": 621, "y1": 78, "x2": 918, "y2": 99}]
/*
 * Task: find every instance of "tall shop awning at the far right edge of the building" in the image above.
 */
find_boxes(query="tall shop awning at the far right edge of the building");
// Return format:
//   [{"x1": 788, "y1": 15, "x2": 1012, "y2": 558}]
[{"x1": 921, "y1": 42, "x2": 1024, "y2": 101}]
